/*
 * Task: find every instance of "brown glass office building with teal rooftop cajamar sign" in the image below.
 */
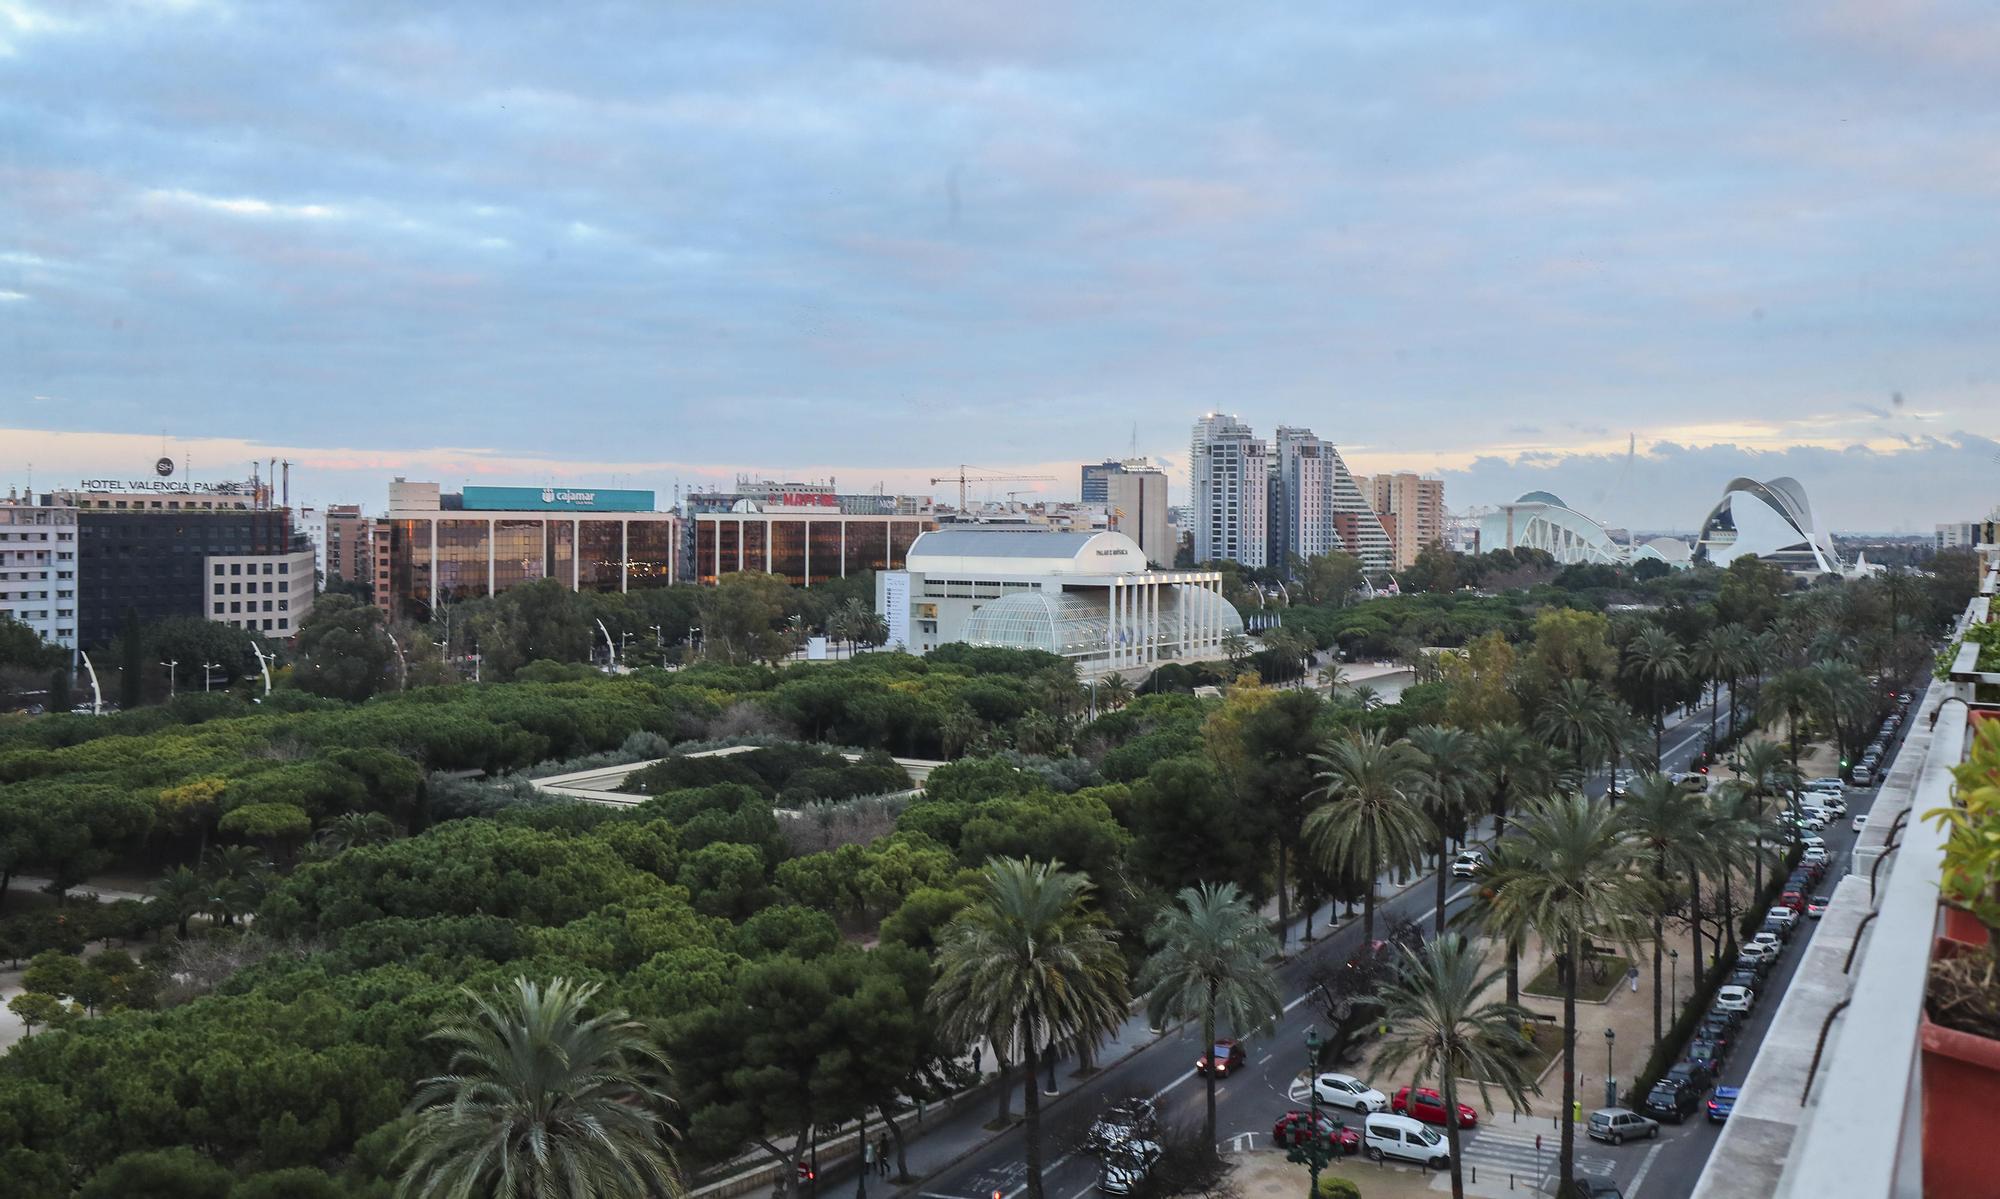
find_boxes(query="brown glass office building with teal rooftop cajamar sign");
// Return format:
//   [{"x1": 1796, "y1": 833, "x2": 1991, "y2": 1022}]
[{"x1": 370, "y1": 478, "x2": 680, "y2": 619}]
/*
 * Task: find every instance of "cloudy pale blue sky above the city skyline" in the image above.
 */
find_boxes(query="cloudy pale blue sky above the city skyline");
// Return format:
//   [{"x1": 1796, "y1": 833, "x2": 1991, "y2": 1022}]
[{"x1": 0, "y1": 0, "x2": 2000, "y2": 532}]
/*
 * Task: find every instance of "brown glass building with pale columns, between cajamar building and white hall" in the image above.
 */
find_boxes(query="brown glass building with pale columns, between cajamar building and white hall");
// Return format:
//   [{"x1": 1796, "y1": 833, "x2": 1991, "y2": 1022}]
[{"x1": 694, "y1": 512, "x2": 938, "y2": 588}]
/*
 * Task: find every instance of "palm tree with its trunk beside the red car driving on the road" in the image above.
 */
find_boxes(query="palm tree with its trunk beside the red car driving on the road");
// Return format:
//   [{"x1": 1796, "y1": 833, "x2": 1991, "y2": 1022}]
[{"x1": 1138, "y1": 883, "x2": 1284, "y2": 1145}]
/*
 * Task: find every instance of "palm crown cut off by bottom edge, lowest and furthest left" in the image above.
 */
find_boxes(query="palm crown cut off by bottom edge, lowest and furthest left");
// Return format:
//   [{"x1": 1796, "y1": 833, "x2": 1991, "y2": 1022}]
[{"x1": 396, "y1": 977, "x2": 686, "y2": 1199}]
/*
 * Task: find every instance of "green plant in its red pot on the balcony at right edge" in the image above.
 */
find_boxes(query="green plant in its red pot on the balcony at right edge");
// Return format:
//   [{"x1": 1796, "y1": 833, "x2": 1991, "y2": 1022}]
[{"x1": 1920, "y1": 721, "x2": 2000, "y2": 1195}]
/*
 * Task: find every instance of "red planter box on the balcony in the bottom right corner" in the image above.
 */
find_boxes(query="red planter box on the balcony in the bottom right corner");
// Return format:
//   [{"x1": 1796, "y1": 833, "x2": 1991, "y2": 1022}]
[{"x1": 1918, "y1": 937, "x2": 2000, "y2": 1199}]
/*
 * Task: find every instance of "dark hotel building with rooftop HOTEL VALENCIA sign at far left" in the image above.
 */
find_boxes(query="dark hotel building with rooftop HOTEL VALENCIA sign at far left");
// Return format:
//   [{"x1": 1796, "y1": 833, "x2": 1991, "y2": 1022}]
[{"x1": 40, "y1": 480, "x2": 300, "y2": 649}]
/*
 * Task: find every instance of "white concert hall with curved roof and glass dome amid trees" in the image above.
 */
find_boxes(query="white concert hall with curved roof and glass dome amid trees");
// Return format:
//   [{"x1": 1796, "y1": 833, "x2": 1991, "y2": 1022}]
[{"x1": 876, "y1": 530, "x2": 1244, "y2": 679}]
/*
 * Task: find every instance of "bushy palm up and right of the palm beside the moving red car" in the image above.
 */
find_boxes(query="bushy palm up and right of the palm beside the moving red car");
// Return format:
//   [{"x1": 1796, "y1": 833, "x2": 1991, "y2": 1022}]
[{"x1": 1306, "y1": 729, "x2": 1434, "y2": 945}]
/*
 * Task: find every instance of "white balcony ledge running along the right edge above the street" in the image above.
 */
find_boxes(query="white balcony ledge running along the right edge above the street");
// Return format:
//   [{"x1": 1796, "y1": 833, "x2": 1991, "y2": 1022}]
[{"x1": 1694, "y1": 548, "x2": 2000, "y2": 1199}]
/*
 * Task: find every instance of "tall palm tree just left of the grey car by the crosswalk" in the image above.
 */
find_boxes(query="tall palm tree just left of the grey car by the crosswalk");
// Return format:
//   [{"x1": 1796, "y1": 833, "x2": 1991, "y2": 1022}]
[{"x1": 1484, "y1": 795, "x2": 1654, "y2": 1195}]
